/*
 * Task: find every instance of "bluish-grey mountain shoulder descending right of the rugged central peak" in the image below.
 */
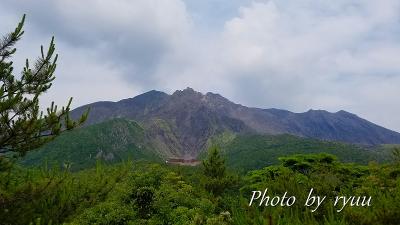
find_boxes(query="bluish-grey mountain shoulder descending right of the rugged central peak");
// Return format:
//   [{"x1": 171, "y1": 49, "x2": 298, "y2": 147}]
[{"x1": 265, "y1": 109, "x2": 399, "y2": 145}]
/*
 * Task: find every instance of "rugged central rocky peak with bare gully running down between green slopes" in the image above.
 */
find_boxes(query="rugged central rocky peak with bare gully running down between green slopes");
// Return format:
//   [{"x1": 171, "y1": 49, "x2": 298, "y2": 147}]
[{"x1": 71, "y1": 89, "x2": 248, "y2": 158}]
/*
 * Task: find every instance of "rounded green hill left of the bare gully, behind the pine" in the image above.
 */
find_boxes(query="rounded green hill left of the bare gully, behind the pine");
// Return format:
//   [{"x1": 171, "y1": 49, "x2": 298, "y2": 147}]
[{"x1": 23, "y1": 119, "x2": 160, "y2": 170}]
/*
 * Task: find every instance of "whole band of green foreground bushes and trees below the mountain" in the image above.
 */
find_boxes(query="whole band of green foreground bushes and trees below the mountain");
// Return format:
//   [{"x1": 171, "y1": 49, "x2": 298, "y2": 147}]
[{"x1": 0, "y1": 149, "x2": 400, "y2": 225}]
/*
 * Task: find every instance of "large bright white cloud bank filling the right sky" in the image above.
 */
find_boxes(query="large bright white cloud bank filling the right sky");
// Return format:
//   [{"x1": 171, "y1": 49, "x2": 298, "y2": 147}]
[{"x1": 173, "y1": 0, "x2": 400, "y2": 130}]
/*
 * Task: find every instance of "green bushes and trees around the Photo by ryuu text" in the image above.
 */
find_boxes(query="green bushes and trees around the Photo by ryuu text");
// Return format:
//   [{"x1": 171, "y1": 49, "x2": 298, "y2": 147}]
[{"x1": 241, "y1": 154, "x2": 400, "y2": 225}]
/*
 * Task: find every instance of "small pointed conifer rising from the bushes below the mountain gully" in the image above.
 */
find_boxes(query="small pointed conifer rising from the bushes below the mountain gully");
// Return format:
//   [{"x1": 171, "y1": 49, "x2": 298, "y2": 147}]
[{"x1": 203, "y1": 146, "x2": 230, "y2": 195}]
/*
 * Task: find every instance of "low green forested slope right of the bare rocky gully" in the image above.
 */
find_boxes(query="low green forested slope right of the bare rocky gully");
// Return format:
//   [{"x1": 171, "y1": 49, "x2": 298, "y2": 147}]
[{"x1": 223, "y1": 135, "x2": 385, "y2": 171}]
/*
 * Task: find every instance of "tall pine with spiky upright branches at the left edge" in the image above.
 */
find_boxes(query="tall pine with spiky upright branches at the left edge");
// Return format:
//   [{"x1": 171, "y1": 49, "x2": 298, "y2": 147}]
[{"x1": 0, "y1": 15, "x2": 88, "y2": 163}]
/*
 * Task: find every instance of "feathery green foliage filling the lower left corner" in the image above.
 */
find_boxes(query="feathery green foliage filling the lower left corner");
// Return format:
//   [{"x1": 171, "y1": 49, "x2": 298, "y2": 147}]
[{"x1": 0, "y1": 161, "x2": 129, "y2": 224}]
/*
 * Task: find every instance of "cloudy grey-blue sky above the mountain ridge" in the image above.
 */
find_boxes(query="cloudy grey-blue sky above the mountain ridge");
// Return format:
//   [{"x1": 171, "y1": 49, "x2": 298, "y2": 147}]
[{"x1": 0, "y1": 0, "x2": 400, "y2": 131}]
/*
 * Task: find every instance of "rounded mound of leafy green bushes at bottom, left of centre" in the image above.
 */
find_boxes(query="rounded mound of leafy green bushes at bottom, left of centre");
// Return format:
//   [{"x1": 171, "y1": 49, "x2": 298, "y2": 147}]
[{"x1": 69, "y1": 163, "x2": 228, "y2": 225}]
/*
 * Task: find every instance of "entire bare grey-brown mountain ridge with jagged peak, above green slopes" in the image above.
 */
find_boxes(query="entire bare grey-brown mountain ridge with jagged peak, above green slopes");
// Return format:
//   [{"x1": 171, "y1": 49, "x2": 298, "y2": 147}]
[{"x1": 71, "y1": 88, "x2": 400, "y2": 157}]
